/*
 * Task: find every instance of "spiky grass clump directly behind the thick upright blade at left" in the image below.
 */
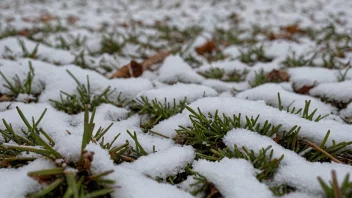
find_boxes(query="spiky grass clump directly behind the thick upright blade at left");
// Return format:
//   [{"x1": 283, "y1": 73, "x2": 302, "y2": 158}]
[{"x1": 50, "y1": 70, "x2": 115, "y2": 114}]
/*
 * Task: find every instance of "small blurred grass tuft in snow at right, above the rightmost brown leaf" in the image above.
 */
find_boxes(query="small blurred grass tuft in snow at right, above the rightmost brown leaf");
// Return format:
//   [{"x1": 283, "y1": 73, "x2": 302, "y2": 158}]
[{"x1": 281, "y1": 52, "x2": 317, "y2": 67}]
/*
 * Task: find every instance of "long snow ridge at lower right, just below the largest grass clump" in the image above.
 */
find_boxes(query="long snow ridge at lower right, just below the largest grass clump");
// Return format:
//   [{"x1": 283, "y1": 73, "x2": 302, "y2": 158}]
[{"x1": 224, "y1": 129, "x2": 352, "y2": 194}]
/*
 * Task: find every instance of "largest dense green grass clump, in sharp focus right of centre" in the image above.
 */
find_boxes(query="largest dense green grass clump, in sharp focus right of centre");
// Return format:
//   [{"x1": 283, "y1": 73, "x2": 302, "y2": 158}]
[{"x1": 175, "y1": 106, "x2": 298, "y2": 154}]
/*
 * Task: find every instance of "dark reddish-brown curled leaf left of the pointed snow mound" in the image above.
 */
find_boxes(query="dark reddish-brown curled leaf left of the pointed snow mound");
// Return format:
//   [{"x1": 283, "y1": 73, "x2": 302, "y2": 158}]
[{"x1": 110, "y1": 60, "x2": 143, "y2": 79}]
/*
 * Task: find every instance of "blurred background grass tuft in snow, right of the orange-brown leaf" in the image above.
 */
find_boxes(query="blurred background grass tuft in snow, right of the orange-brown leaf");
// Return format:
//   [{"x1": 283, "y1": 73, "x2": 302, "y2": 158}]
[{"x1": 239, "y1": 45, "x2": 274, "y2": 65}]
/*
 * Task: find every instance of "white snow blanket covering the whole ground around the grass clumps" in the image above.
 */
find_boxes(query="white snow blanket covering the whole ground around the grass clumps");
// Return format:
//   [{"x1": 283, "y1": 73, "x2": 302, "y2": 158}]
[{"x1": 0, "y1": 0, "x2": 352, "y2": 198}]
